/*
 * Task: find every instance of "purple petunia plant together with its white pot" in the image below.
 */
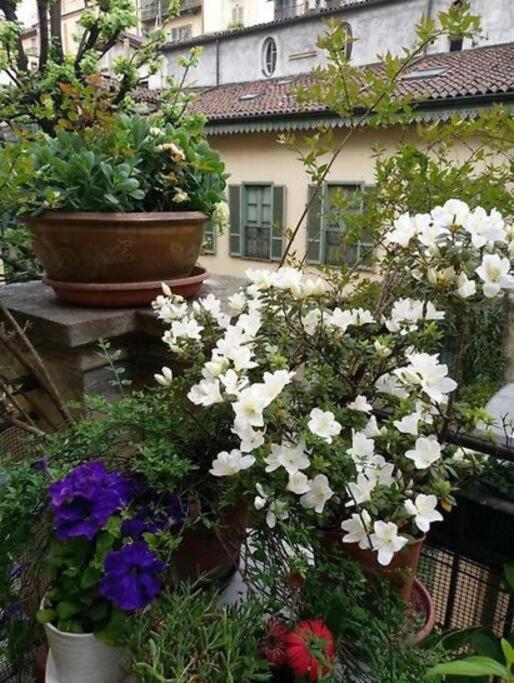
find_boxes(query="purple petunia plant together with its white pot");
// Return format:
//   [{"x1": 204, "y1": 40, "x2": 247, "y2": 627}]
[{"x1": 37, "y1": 460, "x2": 180, "y2": 683}]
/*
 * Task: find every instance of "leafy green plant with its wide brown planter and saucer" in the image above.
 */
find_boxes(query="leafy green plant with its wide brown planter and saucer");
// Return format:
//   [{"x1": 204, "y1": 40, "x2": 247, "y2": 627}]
[{"x1": 15, "y1": 114, "x2": 226, "y2": 305}]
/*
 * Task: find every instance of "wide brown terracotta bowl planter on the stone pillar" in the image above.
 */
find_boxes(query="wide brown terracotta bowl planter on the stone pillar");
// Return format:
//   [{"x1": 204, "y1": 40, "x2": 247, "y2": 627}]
[{"x1": 25, "y1": 211, "x2": 207, "y2": 283}]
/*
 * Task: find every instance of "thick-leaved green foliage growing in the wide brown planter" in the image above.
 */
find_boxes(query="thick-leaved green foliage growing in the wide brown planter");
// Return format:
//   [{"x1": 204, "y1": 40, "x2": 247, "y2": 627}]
[{"x1": 13, "y1": 114, "x2": 226, "y2": 215}]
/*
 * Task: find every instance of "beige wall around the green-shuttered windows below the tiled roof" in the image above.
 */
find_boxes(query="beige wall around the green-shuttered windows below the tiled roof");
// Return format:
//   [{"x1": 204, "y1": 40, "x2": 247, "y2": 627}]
[{"x1": 200, "y1": 125, "x2": 401, "y2": 275}]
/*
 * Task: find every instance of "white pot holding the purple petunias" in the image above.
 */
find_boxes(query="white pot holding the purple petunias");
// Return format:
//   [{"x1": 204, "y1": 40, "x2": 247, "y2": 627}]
[{"x1": 45, "y1": 624, "x2": 126, "y2": 683}]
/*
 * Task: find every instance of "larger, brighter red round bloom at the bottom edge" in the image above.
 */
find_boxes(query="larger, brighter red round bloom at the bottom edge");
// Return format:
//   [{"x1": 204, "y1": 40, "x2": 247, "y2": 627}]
[{"x1": 285, "y1": 619, "x2": 335, "y2": 682}]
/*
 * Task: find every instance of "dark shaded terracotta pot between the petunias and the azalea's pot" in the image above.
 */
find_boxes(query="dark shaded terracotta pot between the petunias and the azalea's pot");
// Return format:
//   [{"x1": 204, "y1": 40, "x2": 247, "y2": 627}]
[{"x1": 172, "y1": 506, "x2": 248, "y2": 581}]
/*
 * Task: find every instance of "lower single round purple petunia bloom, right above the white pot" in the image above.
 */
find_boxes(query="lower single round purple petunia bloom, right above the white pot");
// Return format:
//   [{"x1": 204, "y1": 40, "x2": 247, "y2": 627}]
[{"x1": 100, "y1": 541, "x2": 166, "y2": 611}]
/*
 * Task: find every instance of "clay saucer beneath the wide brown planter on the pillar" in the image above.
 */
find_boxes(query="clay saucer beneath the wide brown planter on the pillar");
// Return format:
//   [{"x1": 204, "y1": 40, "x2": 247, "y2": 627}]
[{"x1": 43, "y1": 266, "x2": 209, "y2": 308}]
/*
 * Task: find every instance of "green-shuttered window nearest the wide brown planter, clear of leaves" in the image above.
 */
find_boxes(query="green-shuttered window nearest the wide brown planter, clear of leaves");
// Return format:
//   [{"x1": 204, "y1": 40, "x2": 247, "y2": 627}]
[{"x1": 229, "y1": 183, "x2": 285, "y2": 261}]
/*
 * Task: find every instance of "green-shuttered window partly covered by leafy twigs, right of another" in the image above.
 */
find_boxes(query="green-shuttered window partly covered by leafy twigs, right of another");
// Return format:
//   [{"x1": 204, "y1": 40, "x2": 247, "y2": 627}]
[{"x1": 307, "y1": 183, "x2": 373, "y2": 266}]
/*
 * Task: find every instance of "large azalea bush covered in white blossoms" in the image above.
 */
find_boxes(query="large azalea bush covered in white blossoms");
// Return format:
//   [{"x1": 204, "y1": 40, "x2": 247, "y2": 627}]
[{"x1": 154, "y1": 200, "x2": 508, "y2": 565}]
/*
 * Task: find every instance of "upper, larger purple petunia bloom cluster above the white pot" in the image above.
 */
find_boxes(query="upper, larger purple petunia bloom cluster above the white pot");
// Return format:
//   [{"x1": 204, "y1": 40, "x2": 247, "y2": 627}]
[{"x1": 49, "y1": 461, "x2": 134, "y2": 541}]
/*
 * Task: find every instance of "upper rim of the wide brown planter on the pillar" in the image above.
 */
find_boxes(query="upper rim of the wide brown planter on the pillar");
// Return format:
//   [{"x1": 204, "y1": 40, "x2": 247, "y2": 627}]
[{"x1": 22, "y1": 211, "x2": 209, "y2": 224}]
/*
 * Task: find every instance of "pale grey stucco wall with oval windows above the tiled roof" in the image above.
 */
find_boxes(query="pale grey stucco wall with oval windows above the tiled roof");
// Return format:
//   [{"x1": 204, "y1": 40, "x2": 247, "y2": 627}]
[{"x1": 166, "y1": 0, "x2": 514, "y2": 86}]
